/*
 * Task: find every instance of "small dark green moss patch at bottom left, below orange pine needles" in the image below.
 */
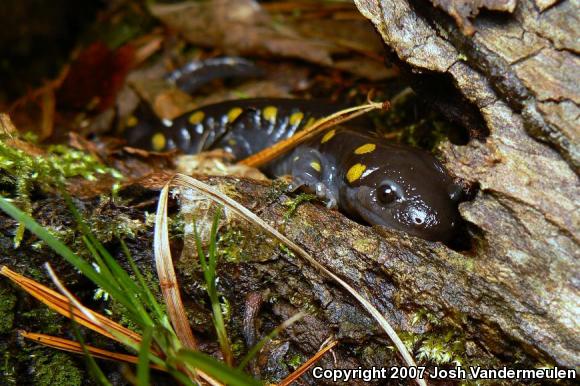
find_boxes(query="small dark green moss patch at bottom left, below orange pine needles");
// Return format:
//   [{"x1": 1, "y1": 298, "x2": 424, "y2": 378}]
[{"x1": 31, "y1": 349, "x2": 85, "y2": 386}]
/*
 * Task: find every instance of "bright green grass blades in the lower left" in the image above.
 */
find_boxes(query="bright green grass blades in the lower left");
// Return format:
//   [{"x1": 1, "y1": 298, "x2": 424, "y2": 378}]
[{"x1": 0, "y1": 196, "x2": 261, "y2": 386}]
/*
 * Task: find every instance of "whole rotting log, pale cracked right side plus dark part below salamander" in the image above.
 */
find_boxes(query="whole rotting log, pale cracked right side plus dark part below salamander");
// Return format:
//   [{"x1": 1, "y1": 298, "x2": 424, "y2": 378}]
[{"x1": 0, "y1": 0, "x2": 580, "y2": 384}]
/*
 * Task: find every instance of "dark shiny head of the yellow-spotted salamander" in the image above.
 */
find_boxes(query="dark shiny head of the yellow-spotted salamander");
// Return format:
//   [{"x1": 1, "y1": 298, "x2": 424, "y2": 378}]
[{"x1": 344, "y1": 147, "x2": 461, "y2": 241}]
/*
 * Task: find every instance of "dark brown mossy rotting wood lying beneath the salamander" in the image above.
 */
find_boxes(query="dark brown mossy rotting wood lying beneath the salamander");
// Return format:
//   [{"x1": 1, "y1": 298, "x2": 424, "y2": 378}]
[{"x1": 0, "y1": 169, "x2": 576, "y2": 384}]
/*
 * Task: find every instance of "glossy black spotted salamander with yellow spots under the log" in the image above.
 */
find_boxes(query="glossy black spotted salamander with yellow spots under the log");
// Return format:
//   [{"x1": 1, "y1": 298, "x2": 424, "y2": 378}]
[{"x1": 127, "y1": 98, "x2": 461, "y2": 241}]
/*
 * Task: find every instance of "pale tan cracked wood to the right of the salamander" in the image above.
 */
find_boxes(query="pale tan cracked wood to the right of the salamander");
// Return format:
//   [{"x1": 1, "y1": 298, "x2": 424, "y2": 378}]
[{"x1": 355, "y1": 0, "x2": 580, "y2": 367}]
